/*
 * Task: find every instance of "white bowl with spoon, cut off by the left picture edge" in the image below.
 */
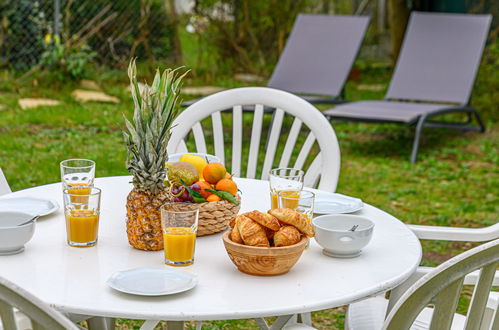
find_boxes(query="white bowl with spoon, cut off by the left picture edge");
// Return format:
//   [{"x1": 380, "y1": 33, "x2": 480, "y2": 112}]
[{"x1": 0, "y1": 211, "x2": 36, "y2": 255}]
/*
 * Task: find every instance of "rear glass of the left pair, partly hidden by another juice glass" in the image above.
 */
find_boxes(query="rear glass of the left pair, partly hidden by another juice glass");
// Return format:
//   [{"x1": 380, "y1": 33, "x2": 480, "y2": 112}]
[{"x1": 61, "y1": 159, "x2": 95, "y2": 195}]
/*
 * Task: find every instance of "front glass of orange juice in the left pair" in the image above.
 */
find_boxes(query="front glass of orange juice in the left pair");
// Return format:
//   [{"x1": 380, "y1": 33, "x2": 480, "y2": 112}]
[{"x1": 63, "y1": 187, "x2": 101, "y2": 247}]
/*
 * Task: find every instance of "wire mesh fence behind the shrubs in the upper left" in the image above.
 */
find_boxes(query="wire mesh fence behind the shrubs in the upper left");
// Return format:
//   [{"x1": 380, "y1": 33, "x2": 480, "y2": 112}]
[{"x1": 0, "y1": 0, "x2": 176, "y2": 69}]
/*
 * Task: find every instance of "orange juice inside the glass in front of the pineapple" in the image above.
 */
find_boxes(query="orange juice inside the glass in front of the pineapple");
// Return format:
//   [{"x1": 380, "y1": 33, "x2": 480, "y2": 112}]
[{"x1": 163, "y1": 227, "x2": 196, "y2": 266}]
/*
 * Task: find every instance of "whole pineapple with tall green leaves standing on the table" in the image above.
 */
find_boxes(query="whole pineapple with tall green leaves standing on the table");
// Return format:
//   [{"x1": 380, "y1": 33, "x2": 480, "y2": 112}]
[{"x1": 123, "y1": 60, "x2": 187, "y2": 251}]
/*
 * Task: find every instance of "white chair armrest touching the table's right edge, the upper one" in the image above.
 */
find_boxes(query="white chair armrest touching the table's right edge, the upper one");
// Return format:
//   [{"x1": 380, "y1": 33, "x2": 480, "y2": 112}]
[{"x1": 408, "y1": 223, "x2": 499, "y2": 242}]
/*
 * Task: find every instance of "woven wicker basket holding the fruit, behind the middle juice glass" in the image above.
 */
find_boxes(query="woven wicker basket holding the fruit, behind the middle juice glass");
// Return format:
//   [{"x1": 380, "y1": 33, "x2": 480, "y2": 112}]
[{"x1": 197, "y1": 195, "x2": 241, "y2": 236}]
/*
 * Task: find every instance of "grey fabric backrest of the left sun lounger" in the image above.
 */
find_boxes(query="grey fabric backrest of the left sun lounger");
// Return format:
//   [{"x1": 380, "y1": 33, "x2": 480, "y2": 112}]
[{"x1": 268, "y1": 14, "x2": 369, "y2": 96}]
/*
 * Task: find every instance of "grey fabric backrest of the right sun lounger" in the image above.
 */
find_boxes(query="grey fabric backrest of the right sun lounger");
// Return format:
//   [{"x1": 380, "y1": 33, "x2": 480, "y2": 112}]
[{"x1": 386, "y1": 12, "x2": 492, "y2": 104}]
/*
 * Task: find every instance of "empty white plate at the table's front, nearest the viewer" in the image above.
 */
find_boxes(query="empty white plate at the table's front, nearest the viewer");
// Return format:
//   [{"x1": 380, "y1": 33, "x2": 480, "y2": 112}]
[{"x1": 107, "y1": 267, "x2": 198, "y2": 296}]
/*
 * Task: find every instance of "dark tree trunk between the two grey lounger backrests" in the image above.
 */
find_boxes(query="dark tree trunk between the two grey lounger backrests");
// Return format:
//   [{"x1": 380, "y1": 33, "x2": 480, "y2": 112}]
[{"x1": 388, "y1": 0, "x2": 409, "y2": 63}]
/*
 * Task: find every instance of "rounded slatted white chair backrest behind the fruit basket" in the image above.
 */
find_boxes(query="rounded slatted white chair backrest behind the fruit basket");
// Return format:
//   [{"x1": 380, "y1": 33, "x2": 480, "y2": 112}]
[{"x1": 168, "y1": 87, "x2": 340, "y2": 192}]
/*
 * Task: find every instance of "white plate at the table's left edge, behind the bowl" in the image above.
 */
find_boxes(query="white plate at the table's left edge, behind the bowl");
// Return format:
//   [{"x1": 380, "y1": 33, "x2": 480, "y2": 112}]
[{"x1": 0, "y1": 197, "x2": 59, "y2": 216}]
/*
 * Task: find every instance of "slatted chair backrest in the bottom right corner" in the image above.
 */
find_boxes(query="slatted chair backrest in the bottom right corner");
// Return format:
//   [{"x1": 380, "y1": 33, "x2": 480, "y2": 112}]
[{"x1": 383, "y1": 239, "x2": 499, "y2": 330}]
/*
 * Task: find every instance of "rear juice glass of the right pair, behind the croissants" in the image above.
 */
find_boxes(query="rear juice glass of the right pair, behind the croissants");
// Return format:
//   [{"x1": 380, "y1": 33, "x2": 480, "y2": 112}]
[{"x1": 269, "y1": 167, "x2": 304, "y2": 209}]
